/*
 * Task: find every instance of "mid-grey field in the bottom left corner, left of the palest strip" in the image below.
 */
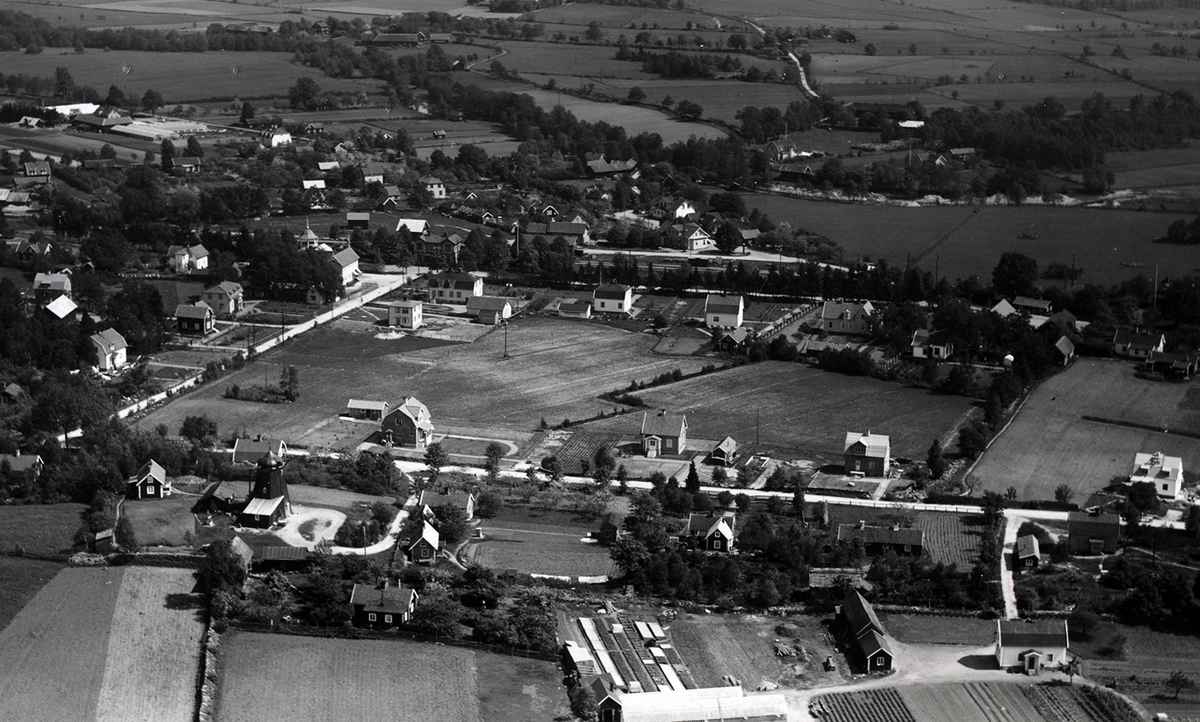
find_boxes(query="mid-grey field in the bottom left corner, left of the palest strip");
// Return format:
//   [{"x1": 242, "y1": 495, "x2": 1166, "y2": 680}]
[{"x1": 0, "y1": 567, "x2": 124, "y2": 722}]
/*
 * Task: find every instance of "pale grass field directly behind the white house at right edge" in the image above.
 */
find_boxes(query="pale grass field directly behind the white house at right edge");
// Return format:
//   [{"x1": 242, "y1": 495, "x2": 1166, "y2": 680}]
[{"x1": 968, "y1": 359, "x2": 1200, "y2": 499}]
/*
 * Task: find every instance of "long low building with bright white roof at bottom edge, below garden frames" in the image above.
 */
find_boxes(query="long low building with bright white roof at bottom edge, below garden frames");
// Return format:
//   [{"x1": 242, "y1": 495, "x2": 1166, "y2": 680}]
[{"x1": 592, "y1": 676, "x2": 787, "y2": 722}]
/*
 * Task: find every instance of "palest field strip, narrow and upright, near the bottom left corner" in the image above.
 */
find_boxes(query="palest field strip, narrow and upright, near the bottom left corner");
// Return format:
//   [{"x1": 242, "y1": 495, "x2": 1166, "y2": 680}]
[{"x1": 96, "y1": 566, "x2": 205, "y2": 722}]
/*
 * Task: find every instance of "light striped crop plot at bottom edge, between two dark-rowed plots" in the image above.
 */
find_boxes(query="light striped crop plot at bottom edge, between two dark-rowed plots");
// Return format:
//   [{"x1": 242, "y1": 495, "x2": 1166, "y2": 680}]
[{"x1": 900, "y1": 682, "x2": 1042, "y2": 722}]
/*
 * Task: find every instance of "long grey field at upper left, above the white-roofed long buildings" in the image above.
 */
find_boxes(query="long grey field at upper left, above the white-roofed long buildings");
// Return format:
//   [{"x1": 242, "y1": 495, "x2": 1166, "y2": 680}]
[{"x1": 0, "y1": 48, "x2": 378, "y2": 103}]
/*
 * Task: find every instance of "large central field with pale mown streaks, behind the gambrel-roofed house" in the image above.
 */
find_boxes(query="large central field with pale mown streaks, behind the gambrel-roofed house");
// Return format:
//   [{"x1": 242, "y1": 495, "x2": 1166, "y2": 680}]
[{"x1": 140, "y1": 318, "x2": 705, "y2": 444}]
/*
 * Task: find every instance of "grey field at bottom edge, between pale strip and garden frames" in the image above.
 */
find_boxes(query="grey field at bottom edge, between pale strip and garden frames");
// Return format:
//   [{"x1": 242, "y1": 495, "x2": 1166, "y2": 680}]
[{"x1": 215, "y1": 632, "x2": 566, "y2": 722}]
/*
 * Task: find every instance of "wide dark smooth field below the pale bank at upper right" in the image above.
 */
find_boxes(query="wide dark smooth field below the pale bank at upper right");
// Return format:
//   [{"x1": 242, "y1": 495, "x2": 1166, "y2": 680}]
[{"x1": 746, "y1": 196, "x2": 1200, "y2": 284}]
